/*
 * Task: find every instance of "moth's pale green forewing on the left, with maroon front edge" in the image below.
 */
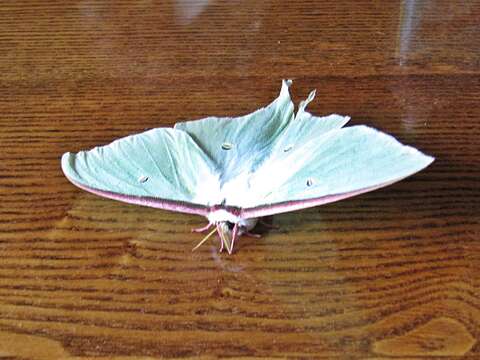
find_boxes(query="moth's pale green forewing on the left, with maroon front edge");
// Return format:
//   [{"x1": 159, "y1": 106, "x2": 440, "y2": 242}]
[{"x1": 62, "y1": 128, "x2": 218, "y2": 215}]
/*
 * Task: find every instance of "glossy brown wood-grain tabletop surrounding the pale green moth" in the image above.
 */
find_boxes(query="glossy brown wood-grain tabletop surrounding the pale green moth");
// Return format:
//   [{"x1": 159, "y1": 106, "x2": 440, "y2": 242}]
[{"x1": 0, "y1": 0, "x2": 480, "y2": 359}]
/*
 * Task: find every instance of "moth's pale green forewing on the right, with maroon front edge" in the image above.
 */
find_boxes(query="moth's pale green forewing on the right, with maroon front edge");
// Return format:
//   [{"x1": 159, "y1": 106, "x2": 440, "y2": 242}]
[{"x1": 237, "y1": 126, "x2": 434, "y2": 218}]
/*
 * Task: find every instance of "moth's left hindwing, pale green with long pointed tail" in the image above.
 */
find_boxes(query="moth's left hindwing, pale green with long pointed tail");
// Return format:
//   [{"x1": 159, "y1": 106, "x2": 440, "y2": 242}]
[{"x1": 175, "y1": 80, "x2": 293, "y2": 183}]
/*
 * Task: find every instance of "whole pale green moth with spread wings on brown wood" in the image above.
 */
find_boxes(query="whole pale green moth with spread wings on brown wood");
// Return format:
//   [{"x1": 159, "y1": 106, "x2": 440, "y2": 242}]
[{"x1": 61, "y1": 80, "x2": 434, "y2": 254}]
